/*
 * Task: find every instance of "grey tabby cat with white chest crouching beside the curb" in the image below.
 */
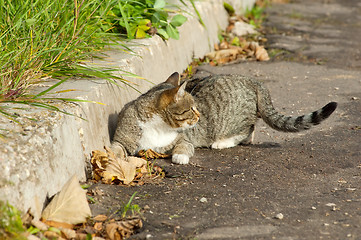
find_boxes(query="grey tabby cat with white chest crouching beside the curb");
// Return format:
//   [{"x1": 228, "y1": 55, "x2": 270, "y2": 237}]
[{"x1": 112, "y1": 72, "x2": 337, "y2": 164}]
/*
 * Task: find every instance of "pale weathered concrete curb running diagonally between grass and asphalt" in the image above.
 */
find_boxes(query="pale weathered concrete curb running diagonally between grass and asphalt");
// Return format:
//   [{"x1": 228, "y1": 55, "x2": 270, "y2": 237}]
[{"x1": 0, "y1": 0, "x2": 255, "y2": 217}]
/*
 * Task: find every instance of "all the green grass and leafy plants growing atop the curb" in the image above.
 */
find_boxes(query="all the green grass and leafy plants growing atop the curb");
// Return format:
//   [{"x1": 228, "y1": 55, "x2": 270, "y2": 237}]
[{"x1": 0, "y1": 0, "x2": 197, "y2": 133}]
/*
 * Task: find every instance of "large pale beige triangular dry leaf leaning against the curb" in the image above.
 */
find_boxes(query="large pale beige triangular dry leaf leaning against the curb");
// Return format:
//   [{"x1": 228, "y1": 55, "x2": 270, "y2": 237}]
[{"x1": 42, "y1": 175, "x2": 91, "y2": 224}]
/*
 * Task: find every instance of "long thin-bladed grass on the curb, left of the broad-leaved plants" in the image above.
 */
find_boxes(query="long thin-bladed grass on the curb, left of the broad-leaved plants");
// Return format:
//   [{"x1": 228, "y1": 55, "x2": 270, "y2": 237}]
[{"x1": 0, "y1": 0, "x2": 128, "y2": 123}]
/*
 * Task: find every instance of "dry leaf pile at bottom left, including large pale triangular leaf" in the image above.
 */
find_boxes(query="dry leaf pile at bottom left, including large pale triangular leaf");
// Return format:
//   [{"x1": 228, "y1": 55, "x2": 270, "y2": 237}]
[{"x1": 22, "y1": 176, "x2": 150, "y2": 240}]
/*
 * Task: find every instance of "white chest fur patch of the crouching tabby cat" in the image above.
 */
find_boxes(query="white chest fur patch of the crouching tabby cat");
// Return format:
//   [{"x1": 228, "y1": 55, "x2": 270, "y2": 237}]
[{"x1": 138, "y1": 116, "x2": 178, "y2": 151}]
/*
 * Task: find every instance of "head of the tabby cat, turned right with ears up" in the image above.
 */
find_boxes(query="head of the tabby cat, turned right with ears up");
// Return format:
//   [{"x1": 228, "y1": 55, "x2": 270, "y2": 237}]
[{"x1": 157, "y1": 72, "x2": 200, "y2": 130}]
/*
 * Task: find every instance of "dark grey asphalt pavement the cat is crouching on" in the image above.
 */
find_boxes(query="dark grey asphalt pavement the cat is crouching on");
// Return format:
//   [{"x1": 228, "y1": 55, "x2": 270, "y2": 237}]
[{"x1": 91, "y1": 0, "x2": 361, "y2": 239}]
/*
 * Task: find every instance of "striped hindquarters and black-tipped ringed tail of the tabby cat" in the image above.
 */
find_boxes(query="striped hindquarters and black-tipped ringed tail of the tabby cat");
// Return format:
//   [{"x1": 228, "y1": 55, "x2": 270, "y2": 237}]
[{"x1": 186, "y1": 75, "x2": 337, "y2": 148}]
